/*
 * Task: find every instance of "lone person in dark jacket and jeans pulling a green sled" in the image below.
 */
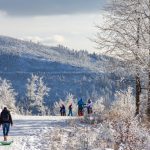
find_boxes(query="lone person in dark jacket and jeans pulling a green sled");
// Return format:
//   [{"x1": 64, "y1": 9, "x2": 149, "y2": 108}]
[{"x1": 0, "y1": 107, "x2": 13, "y2": 141}]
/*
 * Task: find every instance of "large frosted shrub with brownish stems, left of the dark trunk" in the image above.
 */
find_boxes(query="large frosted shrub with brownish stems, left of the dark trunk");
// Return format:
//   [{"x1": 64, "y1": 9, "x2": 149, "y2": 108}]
[{"x1": 107, "y1": 87, "x2": 150, "y2": 150}]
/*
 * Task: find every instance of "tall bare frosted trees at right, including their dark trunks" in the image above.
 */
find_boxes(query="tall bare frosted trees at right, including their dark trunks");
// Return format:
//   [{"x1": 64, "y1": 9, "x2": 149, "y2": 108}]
[{"x1": 96, "y1": 0, "x2": 150, "y2": 114}]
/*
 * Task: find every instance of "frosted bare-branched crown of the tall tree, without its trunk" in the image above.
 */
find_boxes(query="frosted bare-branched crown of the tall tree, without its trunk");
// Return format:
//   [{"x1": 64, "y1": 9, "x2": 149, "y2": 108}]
[{"x1": 96, "y1": 0, "x2": 149, "y2": 71}]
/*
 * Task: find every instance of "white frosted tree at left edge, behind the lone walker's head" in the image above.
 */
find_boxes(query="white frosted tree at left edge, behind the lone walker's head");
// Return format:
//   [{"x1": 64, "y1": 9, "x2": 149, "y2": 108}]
[{"x1": 0, "y1": 78, "x2": 17, "y2": 111}]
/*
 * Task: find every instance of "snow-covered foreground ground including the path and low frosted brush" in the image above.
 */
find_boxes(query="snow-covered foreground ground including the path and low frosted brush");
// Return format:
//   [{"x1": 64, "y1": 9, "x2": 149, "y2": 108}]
[{"x1": 0, "y1": 115, "x2": 116, "y2": 150}]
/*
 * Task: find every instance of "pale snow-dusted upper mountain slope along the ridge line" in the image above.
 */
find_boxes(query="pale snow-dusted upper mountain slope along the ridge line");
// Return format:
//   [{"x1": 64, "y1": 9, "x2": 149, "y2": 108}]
[{"x1": 0, "y1": 36, "x2": 113, "y2": 72}]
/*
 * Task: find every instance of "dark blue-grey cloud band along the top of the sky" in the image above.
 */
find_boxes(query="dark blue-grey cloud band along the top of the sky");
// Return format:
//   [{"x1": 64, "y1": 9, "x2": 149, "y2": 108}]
[{"x1": 0, "y1": 0, "x2": 105, "y2": 16}]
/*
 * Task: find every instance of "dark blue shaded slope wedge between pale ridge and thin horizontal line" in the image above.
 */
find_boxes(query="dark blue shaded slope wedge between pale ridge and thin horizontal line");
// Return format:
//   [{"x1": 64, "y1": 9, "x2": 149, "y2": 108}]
[{"x1": 0, "y1": 53, "x2": 85, "y2": 73}]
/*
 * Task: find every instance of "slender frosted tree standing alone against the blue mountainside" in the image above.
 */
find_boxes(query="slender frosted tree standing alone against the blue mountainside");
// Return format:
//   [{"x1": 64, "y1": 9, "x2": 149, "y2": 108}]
[{"x1": 26, "y1": 74, "x2": 50, "y2": 114}]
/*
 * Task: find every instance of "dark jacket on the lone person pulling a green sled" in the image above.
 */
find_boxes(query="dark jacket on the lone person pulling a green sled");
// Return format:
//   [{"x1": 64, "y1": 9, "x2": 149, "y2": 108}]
[{"x1": 0, "y1": 109, "x2": 13, "y2": 124}]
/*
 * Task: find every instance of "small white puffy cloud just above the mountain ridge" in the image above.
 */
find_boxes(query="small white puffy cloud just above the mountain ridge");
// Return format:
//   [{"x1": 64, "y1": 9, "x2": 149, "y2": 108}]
[{"x1": 21, "y1": 34, "x2": 65, "y2": 45}]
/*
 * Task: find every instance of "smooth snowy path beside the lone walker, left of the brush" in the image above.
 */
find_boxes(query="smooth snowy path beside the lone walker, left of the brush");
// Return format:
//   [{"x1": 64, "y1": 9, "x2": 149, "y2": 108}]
[{"x1": 0, "y1": 116, "x2": 77, "y2": 150}]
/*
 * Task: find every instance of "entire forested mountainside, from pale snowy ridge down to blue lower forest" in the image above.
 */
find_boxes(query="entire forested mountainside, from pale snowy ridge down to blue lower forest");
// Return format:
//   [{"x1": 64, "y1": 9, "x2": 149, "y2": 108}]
[{"x1": 0, "y1": 36, "x2": 120, "y2": 109}]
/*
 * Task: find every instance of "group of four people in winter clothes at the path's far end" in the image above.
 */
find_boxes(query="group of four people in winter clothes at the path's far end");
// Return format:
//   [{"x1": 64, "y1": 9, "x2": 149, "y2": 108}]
[{"x1": 60, "y1": 98, "x2": 93, "y2": 116}]
